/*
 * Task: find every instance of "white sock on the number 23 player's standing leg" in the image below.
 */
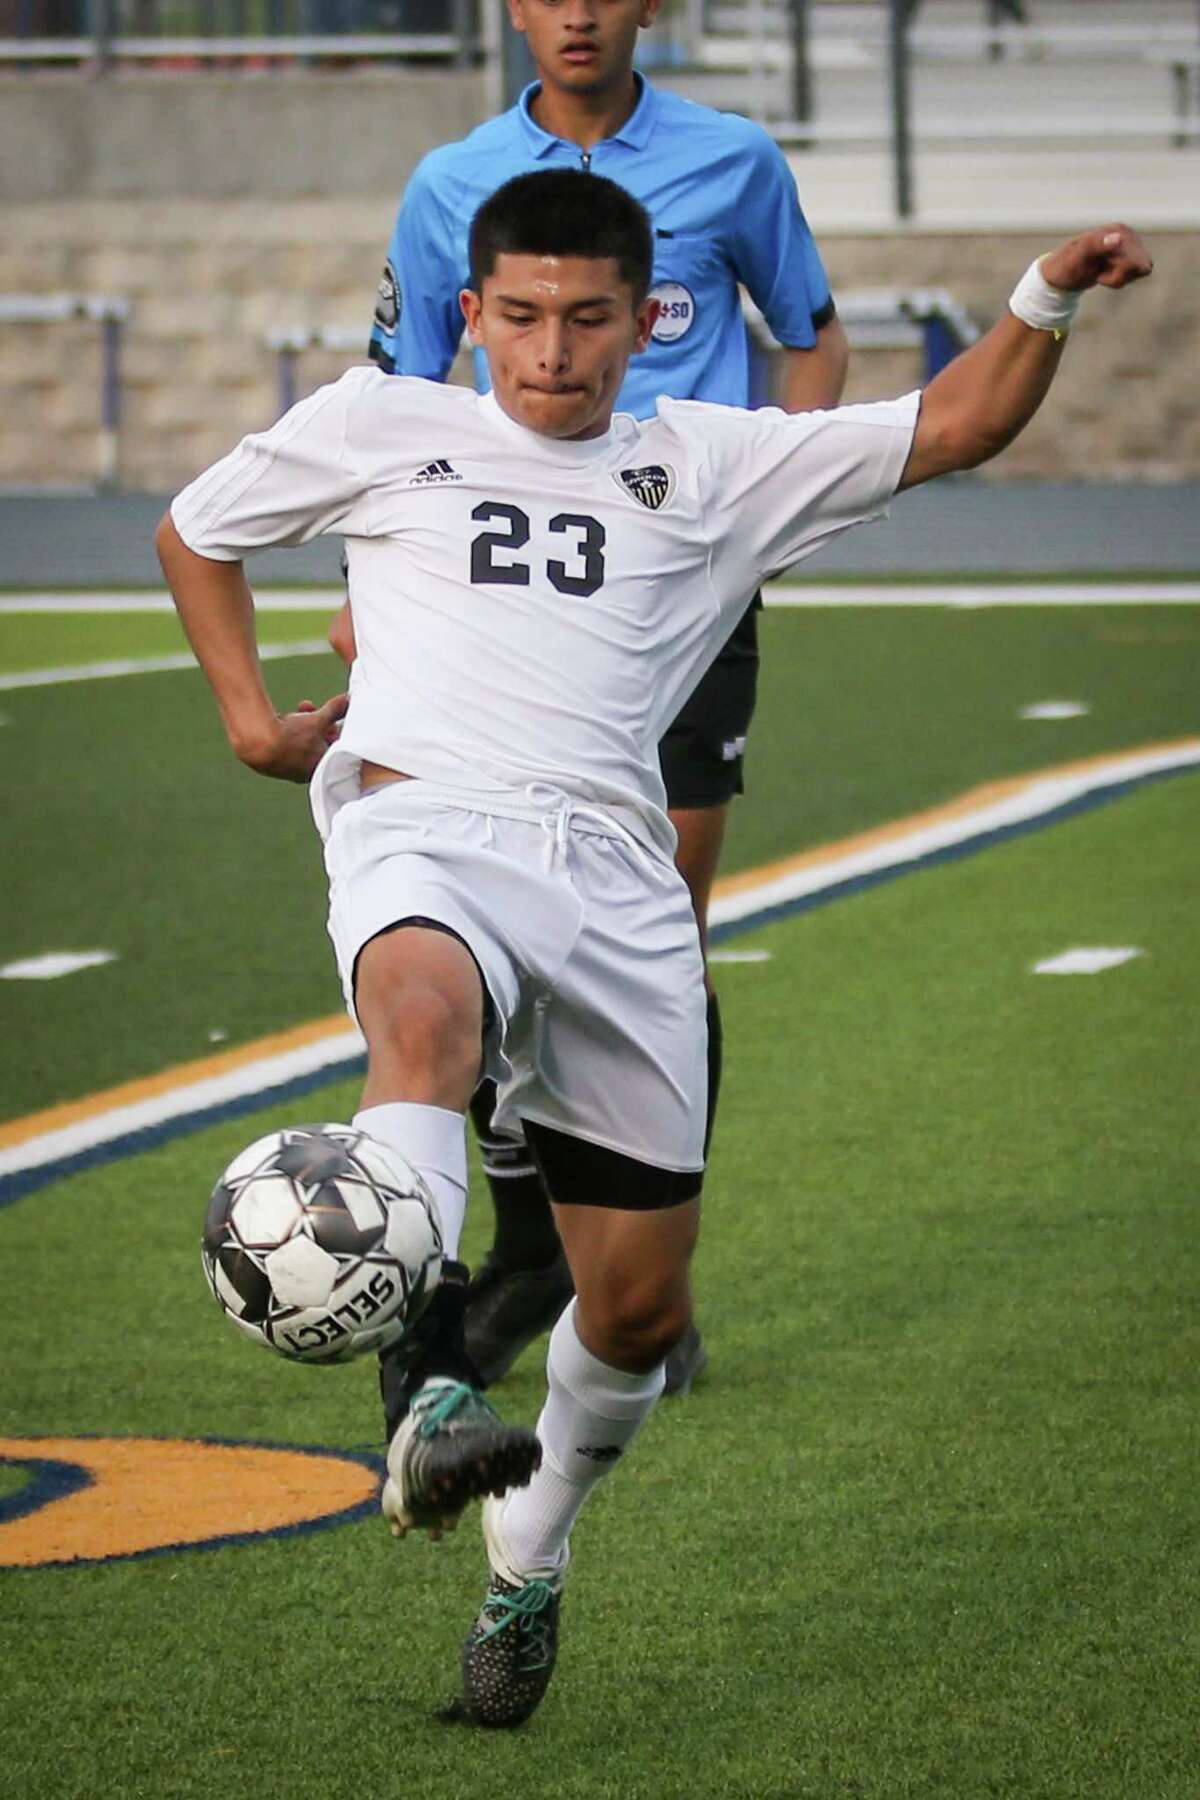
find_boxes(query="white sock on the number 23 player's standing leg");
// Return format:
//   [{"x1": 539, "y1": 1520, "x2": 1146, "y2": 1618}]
[{"x1": 502, "y1": 1300, "x2": 662, "y2": 1575}]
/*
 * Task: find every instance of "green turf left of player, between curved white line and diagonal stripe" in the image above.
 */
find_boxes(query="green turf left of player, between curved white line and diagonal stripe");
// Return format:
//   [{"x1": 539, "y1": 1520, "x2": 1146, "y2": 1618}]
[{"x1": 0, "y1": 655, "x2": 342, "y2": 1114}]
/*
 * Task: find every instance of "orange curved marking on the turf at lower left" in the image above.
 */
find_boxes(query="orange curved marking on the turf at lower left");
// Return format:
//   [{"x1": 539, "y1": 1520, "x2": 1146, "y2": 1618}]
[{"x1": 0, "y1": 1438, "x2": 378, "y2": 1568}]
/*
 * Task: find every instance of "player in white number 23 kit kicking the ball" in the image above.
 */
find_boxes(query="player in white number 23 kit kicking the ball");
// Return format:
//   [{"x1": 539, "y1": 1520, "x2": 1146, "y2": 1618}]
[{"x1": 158, "y1": 171, "x2": 1150, "y2": 1726}]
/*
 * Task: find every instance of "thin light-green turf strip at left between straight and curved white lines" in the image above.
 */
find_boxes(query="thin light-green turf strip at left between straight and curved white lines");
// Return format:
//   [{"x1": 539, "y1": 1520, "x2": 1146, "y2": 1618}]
[{"x1": 0, "y1": 607, "x2": 333, "y2": 679}]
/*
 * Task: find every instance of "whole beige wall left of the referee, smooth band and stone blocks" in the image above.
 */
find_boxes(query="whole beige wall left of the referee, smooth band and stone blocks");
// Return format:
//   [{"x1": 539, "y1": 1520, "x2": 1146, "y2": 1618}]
[{"x1": 0, "y1": 67, "x2": 488, "y2": 491}]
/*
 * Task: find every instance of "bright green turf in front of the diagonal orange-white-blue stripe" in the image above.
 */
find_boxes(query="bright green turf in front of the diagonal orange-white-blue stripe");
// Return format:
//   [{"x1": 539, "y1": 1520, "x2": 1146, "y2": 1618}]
[{"x1": 0, "y1": 778, "x2": 1200, "y2": 1800}]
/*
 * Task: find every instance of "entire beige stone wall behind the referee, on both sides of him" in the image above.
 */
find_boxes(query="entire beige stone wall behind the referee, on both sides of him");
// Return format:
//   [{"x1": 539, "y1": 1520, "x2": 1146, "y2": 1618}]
[{"x1": 0, "y1": 74, "x2": 1200, "y2": 491}]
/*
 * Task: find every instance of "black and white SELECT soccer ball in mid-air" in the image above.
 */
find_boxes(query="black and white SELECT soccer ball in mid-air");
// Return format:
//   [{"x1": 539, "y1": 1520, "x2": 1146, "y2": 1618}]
[{"x1": 201, "y1": 1125, "x2": 443, "y2": 1363}]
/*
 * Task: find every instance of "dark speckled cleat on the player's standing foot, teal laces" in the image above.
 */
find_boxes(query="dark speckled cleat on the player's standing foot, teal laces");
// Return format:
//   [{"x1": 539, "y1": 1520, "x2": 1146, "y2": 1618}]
[{"x1": 462, "y1": 1499, "x2": 567, "y2": 1730}]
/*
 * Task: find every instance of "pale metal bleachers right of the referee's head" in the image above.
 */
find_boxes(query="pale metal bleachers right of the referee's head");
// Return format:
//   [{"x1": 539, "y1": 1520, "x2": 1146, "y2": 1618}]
[{"x1": 644, "y1": 0, "x2": 1200, "y2": 146}]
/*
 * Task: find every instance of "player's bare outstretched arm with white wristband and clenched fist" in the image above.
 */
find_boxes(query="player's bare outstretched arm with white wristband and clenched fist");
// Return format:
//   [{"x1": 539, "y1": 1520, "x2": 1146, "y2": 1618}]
[{"x1": 900, "y1": 225, "x2": 1153, "y2": 490}]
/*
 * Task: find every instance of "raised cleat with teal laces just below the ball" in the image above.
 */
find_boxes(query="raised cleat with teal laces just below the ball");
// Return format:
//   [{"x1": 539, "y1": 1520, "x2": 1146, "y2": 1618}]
[{"x1": 381, "y1": 1375, "x2": 542, "y2": 1537}]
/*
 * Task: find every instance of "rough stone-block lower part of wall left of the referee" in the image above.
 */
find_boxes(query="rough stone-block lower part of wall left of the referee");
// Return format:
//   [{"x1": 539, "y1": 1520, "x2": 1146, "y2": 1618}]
[{"x1": 0, "y1": 196, "x2": 394, "y2": 490}]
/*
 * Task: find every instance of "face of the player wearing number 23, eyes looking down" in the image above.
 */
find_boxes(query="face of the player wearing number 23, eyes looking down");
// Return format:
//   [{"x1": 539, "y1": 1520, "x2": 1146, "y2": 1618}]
[{"x1": 462, "y1": 250, "x2": 657, "y2": 437}]
